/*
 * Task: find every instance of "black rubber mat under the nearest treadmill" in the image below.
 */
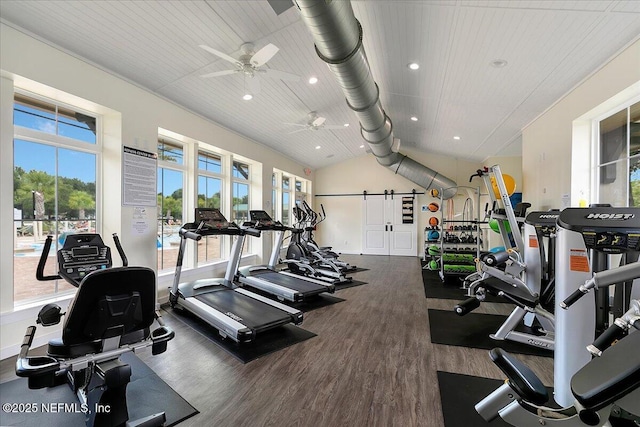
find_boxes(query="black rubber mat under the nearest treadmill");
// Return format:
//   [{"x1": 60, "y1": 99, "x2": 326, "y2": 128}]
[{"x1": 163, "y1": 309, "x2": 317, "y2": 363}]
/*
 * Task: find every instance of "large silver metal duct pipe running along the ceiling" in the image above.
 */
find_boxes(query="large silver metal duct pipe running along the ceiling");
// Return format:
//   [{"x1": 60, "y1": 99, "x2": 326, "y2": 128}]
[{"x1": 294, "y1": 0, "x2": 457, "y2": 199}]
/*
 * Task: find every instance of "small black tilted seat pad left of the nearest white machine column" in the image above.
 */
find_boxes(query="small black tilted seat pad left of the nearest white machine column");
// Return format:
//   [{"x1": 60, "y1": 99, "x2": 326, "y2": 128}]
[{"x1": 489, "y1": 348, "x2": 549, "y2": 405}]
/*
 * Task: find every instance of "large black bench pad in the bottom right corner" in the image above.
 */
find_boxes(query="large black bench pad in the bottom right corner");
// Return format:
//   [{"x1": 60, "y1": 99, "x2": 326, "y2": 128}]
[{"x1": 571, "y1": 332, "x2": 640, "y2": 411}]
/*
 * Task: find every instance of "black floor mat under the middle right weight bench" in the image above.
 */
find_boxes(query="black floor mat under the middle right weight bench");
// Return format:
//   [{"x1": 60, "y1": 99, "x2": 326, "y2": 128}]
[{"x1": 429, "y1": 310, "x2": 553, "y2": 357}]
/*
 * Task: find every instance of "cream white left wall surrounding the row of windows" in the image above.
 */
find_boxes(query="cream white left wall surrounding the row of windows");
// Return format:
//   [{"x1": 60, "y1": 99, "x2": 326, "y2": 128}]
[{"x1": 0, "y1": 24, "x2": 313, "y2": 357}]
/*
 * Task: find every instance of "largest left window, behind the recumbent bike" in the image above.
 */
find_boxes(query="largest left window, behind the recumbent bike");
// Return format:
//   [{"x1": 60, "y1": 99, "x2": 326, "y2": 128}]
[{"x1": 13, "y1": 93, "x2": 100, "y2": 303}]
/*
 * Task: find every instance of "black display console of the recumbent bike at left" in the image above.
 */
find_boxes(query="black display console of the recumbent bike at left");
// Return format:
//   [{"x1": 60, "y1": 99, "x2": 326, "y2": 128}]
[{"x1": 58, "y1": 234, "x2": 112, "y2": 286}]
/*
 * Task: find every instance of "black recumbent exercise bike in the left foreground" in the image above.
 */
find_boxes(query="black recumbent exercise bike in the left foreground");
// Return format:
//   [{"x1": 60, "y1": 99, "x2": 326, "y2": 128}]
[{"x1": 16, "y1": 234, "x2": 175, "y2": 427}]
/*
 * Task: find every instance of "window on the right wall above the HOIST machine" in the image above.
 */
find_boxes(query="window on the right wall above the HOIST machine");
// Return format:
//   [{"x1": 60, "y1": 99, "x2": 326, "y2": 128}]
[{"x1": 596, "y1": 102, "x2": 640, "y2": 206}]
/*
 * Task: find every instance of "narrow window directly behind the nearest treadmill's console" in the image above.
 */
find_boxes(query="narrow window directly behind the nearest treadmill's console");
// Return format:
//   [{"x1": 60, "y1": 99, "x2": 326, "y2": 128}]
[{"x1": 197, "y1": 151, "x2": 223, "y2": 265}]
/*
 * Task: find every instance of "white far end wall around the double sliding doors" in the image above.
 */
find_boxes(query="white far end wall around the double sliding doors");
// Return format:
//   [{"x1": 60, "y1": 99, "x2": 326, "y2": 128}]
[{"x1": 313, "y1": 150, "x2": 481, "y2": 255}]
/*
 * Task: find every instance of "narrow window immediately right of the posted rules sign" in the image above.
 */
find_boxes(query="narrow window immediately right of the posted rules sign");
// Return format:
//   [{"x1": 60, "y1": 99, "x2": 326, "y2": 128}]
[{"x1": 157, "y1": 138, "x2": 185, "y2": 271}]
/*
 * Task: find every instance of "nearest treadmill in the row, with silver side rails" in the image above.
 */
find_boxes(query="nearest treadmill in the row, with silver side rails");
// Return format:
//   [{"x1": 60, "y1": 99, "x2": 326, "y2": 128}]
[{"x1": 169, "y1": 208, "x2": 303, "y2": 343}]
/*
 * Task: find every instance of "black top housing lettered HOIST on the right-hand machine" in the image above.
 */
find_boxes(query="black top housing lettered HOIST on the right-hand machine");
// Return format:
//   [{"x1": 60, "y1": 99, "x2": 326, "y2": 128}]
[{"x1": 558, "y1": 207, "x2": 640, "y2": 253}]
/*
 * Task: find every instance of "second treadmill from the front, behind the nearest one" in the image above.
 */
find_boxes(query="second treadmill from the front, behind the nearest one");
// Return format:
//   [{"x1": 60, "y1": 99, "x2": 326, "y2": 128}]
[{"x1": 236, "y1": 210, "x2": 336, "y2": 302}]
